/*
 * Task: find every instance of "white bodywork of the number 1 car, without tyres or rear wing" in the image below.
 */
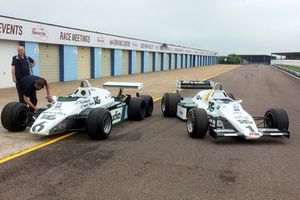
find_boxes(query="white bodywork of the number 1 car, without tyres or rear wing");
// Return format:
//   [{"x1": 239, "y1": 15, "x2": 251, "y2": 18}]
[{"x1": 177, "y1": 89, "x2": 263, "y2": 139}]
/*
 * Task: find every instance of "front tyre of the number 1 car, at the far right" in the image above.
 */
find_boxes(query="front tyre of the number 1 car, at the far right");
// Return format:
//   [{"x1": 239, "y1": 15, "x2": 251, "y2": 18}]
[{"x1": 265, "y1": 108, "x2": 289, "y2": 130}]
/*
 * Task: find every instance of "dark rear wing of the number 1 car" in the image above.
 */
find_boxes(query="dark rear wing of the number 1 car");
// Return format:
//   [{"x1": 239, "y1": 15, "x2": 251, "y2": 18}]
[{"x1": 176, "y1": 80, "x2": 215, "y2": 91}]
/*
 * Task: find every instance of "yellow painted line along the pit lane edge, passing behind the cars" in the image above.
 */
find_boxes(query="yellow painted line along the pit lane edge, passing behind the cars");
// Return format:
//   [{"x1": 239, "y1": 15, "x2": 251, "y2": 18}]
[{"x1": 0, "y1": 70, "x2": 237, "y2": 164}]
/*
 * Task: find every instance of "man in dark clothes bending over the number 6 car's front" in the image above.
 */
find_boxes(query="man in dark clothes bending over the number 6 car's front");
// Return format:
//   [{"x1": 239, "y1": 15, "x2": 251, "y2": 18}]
[{"x1": 19, "y1": 75, "x2": 52, "y2": 111}]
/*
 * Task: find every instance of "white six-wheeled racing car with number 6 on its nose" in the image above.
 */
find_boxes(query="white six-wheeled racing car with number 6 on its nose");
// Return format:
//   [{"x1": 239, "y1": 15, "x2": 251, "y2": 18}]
[{"x1": 1, "y1": 80, "x2": 153, "y2": 139}]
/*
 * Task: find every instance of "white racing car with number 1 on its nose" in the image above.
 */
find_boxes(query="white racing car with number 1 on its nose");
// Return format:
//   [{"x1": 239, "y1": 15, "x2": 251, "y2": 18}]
[{"x1": 161, "y1": 80, "x2": 290, "y2": 139}]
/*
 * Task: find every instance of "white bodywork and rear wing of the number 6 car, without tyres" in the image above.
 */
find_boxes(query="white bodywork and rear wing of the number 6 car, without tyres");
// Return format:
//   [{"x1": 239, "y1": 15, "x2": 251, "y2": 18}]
[{"x1": 30, "y1": 81, "x2": 142, "y2": 135}]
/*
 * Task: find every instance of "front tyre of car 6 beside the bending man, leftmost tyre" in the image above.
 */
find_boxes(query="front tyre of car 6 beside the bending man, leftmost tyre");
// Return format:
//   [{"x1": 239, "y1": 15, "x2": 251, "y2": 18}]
[{"x1": 1, "y1": 102, "x2": 30, "y2": 132}]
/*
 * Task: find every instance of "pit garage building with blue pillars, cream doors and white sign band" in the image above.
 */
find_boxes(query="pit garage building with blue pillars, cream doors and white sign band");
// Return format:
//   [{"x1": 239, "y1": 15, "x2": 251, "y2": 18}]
[{"x1": 0, "y1": 16, "x2": 217, "y2": 88}]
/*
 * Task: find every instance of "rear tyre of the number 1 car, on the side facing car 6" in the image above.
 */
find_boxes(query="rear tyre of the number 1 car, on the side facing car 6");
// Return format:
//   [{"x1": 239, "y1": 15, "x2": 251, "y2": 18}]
[{"x1": 161, "y1": 93, "x2": 182, "y2": 117}]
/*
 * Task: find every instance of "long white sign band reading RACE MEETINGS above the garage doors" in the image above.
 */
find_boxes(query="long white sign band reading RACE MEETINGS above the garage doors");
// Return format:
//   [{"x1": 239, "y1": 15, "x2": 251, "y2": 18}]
[{"x1": 0, "y1": 16, "x2": 217, "y2": 55}]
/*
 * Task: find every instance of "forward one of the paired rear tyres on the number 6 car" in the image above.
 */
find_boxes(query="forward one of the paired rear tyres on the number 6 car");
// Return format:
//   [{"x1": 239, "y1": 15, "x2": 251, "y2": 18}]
[{"x1": 128, "y1": 97, "x2": 147, "y2": 121}]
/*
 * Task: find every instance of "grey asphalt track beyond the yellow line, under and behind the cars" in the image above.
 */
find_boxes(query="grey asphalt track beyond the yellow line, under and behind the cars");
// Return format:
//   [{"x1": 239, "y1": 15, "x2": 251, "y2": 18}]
[{"x1": 0, "y1": 65, "x2": 300, "y2": 200}]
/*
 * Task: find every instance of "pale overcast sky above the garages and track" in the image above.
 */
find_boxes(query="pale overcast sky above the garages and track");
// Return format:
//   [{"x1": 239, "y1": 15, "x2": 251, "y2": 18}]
[{"x1": 0, "y1": 0, "x2": 300, "y2": 54}]
